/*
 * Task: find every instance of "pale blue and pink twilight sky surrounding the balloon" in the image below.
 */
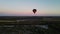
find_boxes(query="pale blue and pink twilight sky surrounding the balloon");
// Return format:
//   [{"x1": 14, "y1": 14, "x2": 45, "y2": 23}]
[{"x1": 0, "y1": 0, "x2": 60, "y2": 16}]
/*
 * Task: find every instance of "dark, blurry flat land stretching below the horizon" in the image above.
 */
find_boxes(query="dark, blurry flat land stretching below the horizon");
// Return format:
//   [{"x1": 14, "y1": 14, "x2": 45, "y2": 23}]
[{"x1": 0, "y1": 16, "x2": 60, "y2": 34}]
